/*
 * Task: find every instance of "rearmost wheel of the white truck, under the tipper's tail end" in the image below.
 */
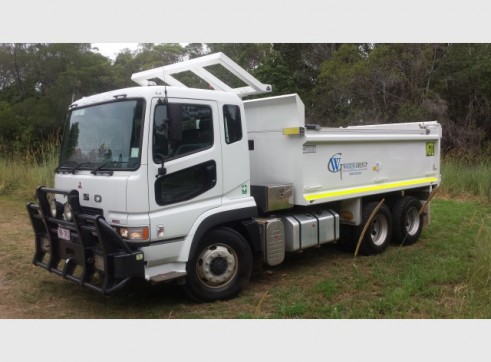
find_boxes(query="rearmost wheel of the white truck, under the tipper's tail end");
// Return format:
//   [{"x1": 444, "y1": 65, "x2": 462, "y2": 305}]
[{"x1": 392, "y1": 196, "x2": 423, "y2": 245}]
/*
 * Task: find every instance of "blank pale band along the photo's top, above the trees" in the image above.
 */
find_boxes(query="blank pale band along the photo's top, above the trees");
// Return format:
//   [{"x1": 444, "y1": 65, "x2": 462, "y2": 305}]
[{"x1": 0, "y1": 0, "x2": 491, "y2": 43}]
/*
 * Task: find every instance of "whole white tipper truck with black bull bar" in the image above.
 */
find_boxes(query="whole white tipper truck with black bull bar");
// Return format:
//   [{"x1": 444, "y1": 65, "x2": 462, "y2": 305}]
[{"x1": 27, "y1": 53, "x2": 442, "y2": 301}]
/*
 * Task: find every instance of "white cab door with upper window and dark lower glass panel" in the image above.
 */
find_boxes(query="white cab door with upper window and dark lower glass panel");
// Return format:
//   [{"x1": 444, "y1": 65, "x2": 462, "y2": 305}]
[{"x1": 148, "y1": 98, "x2": 222, "y2": 242}]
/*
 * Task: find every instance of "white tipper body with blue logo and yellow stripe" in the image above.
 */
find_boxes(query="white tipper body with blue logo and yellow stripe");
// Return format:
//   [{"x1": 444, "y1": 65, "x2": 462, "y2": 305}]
[{"x1": 245, "y1": 96, "x2": 441, "y2": 206}]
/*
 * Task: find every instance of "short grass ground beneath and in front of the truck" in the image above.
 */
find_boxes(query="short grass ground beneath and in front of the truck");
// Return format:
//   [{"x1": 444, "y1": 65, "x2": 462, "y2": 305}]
[{"x1": 0, "y1": 197, "x2": 491, "y2": 319}]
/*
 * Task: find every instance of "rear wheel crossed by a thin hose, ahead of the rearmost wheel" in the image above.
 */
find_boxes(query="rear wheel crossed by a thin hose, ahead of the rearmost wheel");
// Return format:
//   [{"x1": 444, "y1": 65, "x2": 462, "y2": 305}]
[{"x1": 354, "y1": 202, "x2": 392, "y2": 255}]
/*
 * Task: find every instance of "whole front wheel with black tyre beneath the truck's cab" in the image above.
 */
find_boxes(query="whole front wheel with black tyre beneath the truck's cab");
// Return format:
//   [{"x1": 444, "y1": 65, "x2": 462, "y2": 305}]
[{"x1": 185, "y1": 227, "x2": 252, "y2": 302}]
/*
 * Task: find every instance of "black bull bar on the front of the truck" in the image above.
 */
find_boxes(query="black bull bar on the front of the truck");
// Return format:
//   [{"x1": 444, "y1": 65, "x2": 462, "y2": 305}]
[{"x1": 27, "y1": 187, "x2": 144, "y2": 294}]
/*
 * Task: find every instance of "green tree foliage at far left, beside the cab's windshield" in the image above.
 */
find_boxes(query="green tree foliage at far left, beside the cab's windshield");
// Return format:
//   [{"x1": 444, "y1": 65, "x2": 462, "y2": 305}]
[{"x1": 0, "y1": 43, "x2": 115, "y2": 153}]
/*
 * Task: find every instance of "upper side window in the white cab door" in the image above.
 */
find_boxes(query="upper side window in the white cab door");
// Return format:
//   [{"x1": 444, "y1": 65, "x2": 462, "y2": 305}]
[{"x1": 152, "y1": 103, "x2": 213, "y2": 163}]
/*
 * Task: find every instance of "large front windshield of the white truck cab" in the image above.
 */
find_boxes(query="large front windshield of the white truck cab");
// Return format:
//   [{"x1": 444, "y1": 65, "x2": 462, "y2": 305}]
[{"x1": 60, "y1": 99, "x2": 144, "y2": 169}]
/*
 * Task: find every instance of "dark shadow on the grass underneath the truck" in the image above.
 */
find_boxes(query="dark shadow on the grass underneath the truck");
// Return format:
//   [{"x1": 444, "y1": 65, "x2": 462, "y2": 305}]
[{"x1": 60, "y1": 244, "x2": 366, "y2": 318}]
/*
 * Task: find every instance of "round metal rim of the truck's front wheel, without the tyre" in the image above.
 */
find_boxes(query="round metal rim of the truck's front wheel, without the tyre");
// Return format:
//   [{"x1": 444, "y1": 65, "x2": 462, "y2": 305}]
[{"x1": 196, "y1": 244, "x2": 238, "y2": 288}]
